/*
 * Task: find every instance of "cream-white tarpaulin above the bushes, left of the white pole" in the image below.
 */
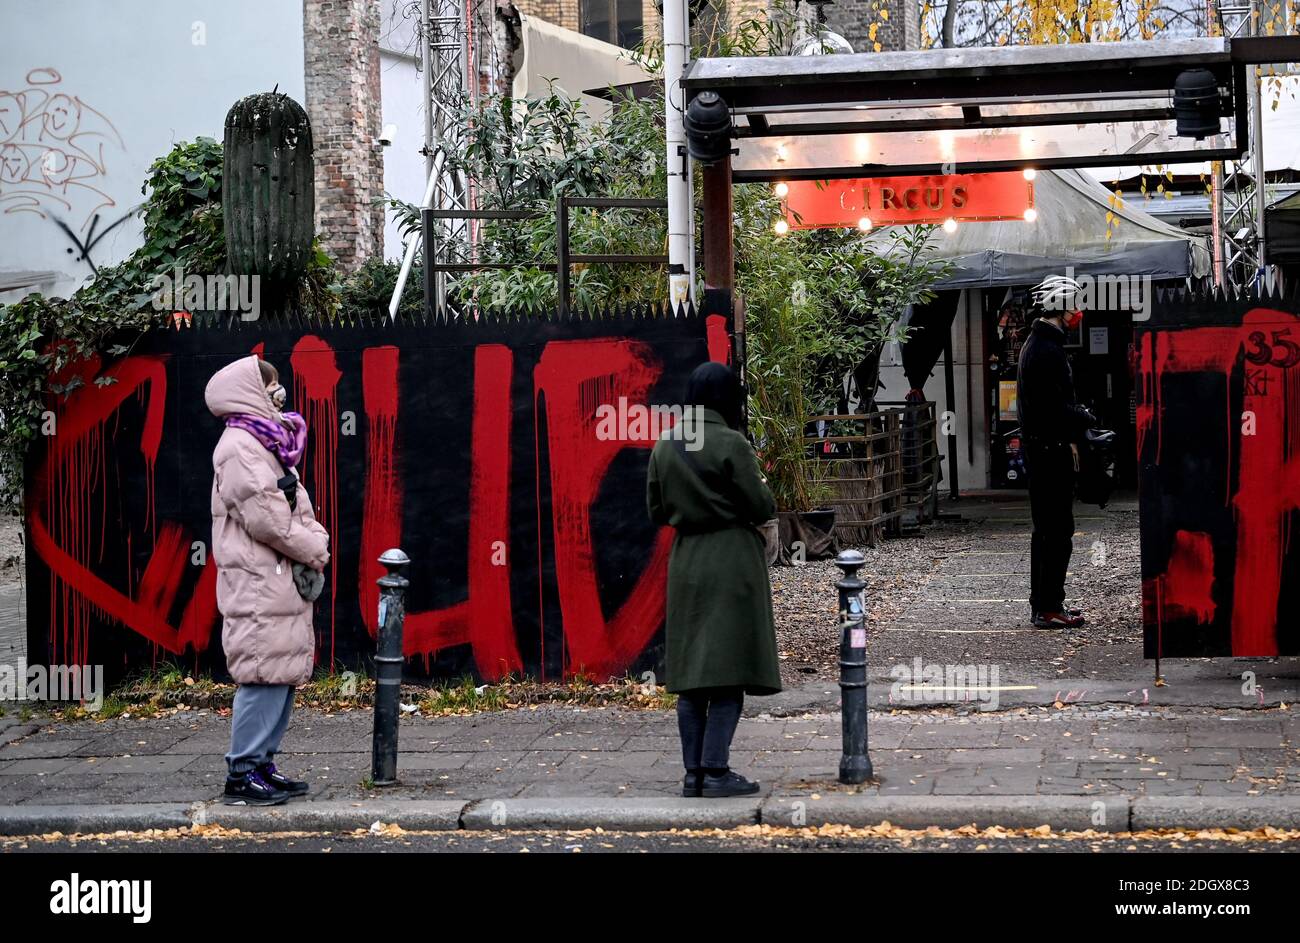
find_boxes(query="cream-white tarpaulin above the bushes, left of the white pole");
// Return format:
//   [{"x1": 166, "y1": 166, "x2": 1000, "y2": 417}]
[{"x1": 511, "y1": 14, "x2": 653, "y2": 118}]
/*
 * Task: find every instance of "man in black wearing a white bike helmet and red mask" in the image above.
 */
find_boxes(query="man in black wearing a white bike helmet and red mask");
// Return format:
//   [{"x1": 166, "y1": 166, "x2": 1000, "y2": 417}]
[{"x1": 1015, "y1": 276, "x2": 1096, "y2": 628}]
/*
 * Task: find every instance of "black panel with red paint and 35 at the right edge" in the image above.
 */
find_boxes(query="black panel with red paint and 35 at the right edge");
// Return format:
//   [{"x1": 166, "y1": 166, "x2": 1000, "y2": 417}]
[{"x1": 1136, "y1": 295, "x2": 1300, "y2": 658}]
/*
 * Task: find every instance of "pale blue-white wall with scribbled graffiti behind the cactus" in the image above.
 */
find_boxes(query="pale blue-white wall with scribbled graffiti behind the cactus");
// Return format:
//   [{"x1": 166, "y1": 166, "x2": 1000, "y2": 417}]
[{"x1": 0, "y1": 0, "x2": 306, "y2": 300}]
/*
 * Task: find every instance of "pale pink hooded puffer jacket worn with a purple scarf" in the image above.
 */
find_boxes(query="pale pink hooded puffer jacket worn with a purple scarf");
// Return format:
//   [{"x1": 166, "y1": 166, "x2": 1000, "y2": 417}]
[{"x1": 204, "y1": 356, "x2": 329, "y2": 684}]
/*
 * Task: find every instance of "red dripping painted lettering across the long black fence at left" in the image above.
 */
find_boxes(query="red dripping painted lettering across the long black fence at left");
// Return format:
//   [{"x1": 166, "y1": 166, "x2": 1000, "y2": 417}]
[{"x1": 29, "y1": 317, "x2": 731, "y2": 678}]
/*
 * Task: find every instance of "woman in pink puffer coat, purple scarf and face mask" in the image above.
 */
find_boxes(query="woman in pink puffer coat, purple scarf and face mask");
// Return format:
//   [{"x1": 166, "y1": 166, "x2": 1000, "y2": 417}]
[{"x1": 204, "y1": 356, "x2": 329, "y2": 805}]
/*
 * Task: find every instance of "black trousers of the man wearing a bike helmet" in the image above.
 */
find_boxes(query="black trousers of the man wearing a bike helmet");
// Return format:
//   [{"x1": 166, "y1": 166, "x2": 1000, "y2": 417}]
[{"x1": 1024, "y1": 444, "x2": 1075, "y2": 613}]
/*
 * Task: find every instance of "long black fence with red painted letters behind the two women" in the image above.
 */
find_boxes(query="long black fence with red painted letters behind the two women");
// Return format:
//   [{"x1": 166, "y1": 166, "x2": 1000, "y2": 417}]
[{"x1": 27, "y1": 313, "x2": 729, "y2": 679}]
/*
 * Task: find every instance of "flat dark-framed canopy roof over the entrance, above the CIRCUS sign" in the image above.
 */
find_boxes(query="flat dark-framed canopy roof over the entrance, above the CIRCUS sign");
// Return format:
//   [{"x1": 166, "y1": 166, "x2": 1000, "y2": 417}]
[{"x1": 683, "y1": 36, "x2": 1300, "y2": 181}]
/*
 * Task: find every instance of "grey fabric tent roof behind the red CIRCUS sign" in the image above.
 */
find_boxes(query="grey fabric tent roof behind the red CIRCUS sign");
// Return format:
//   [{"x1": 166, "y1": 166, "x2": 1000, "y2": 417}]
[{"x1": 871, "y1": 170, "x2": 1210, "y2": 289}]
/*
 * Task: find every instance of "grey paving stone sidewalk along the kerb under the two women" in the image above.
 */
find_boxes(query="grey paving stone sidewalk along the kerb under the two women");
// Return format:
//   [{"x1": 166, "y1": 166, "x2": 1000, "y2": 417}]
[{"x1": 0, "y1": 706, "x2": 1300, "y2": 806}]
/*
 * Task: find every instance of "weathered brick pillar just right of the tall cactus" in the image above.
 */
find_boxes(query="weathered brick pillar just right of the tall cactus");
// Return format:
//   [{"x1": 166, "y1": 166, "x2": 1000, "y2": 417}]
[{"x1": 303, "y1": 0, "x2": 384, "y2": 271}]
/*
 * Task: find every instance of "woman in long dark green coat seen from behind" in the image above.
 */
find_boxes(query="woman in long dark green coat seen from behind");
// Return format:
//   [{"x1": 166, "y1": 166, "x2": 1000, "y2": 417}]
[{"x1": 646, "y1": 363, "x2": 781, "y2": 799}]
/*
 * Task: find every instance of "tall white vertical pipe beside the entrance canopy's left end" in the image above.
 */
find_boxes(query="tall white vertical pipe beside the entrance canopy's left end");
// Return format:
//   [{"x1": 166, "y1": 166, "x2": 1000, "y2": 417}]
[{"x1": 663, "y1": 0, "x2": 696, "y2": 310}]
